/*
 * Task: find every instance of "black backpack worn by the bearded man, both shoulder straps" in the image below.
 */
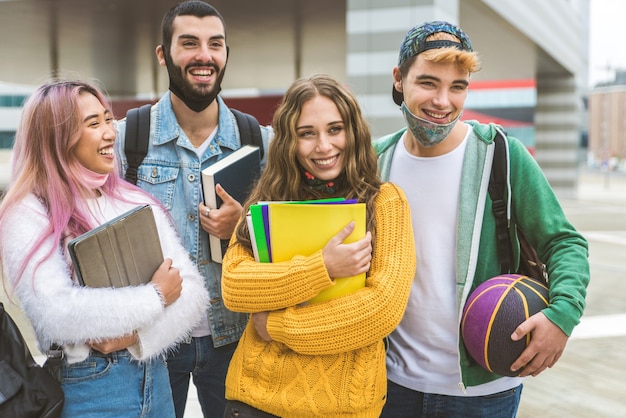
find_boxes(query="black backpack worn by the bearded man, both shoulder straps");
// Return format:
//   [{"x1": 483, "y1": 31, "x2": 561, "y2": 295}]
[{"x1": 124, "y1": 104, "x2": 264, "y2": 184}]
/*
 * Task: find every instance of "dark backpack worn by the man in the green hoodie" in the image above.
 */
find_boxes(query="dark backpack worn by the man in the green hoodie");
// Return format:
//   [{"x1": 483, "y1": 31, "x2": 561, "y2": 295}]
[{"x1": 489, "y1": 128, "x2": 548, "y2": 284}]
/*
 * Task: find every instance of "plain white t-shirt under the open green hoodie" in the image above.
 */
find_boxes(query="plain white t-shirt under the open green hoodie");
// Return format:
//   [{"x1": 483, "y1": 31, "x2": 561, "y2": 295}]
[{"x1": 387, "y1": 128, "x2": 519, "y2": 396}]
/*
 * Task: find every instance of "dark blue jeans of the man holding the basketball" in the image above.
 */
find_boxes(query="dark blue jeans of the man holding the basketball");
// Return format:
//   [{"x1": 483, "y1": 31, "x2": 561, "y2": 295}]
[{"x1": 380, "y1": 380, "x2": 522, "y2": 418}]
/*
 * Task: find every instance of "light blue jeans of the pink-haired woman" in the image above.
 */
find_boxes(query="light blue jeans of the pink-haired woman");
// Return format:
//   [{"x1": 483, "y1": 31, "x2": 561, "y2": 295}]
[{"x1": 61, "y1": 350, "x2": 174, "y2": 418}]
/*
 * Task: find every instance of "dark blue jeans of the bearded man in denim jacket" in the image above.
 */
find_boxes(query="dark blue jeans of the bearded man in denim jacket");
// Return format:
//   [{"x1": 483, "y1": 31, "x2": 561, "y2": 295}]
[{"x1": 167, "y1": 336, "x2": 237, "y2": 418}]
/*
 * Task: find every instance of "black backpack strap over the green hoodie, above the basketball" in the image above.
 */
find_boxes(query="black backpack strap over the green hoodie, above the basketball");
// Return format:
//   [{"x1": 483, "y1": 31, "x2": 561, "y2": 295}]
[{"x1": 489, "y1": 129, "x2": 512, "y2": 274}]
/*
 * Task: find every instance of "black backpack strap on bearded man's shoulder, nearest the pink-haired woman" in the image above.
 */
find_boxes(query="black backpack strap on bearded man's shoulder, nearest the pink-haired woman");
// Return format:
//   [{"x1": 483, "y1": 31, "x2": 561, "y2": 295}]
[{"x1": 124, "y1": 104, "x2": 152, "y2": 184}]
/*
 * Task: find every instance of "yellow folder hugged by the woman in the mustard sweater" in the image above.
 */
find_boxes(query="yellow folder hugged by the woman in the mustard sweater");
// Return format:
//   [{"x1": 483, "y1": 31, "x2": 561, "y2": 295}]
[{"x1": 268, "y1": 203, "x2": 366, "y2": 303}]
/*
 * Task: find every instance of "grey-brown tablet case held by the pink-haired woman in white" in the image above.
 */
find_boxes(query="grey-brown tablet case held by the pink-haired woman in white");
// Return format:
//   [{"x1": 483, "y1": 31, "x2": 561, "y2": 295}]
[{"x1": 67, "y1": 205, "x2": 163, "y2": 287}]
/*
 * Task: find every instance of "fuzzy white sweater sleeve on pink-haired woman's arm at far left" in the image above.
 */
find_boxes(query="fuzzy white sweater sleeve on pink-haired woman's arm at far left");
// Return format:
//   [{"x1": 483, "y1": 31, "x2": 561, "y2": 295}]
[{"x1": 0, "y1": 196, "x2": 164, "y2": 347}]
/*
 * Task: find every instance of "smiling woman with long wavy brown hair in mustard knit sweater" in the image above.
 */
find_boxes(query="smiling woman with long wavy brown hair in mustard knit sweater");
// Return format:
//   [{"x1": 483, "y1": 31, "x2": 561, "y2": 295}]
[{"x1": 222, "y1": 74, "x2": 415, "y2": 417}]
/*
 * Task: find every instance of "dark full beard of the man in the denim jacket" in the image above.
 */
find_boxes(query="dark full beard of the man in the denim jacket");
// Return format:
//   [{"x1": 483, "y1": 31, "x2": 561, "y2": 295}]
[{"x1": 163, "y1": 48, "x2": 226, "y2": 112}]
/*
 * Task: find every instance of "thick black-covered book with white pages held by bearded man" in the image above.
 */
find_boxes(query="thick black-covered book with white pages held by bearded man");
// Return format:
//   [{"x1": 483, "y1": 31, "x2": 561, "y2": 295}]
[{"x1": 202, "y1": 145, "x2": 261, "y2": 263}]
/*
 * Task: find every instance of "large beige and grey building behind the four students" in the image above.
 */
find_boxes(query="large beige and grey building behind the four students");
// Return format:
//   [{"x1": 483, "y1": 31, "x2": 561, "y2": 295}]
[{"x1": 0, "y1": 0, "x2": 589, "y2": 196}]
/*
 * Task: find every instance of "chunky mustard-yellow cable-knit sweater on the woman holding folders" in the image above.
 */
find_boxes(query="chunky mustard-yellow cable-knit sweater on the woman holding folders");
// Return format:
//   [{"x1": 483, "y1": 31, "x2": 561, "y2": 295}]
[{"x1": 222, "y1": 183, "x2": 415, "y2": 417}]
